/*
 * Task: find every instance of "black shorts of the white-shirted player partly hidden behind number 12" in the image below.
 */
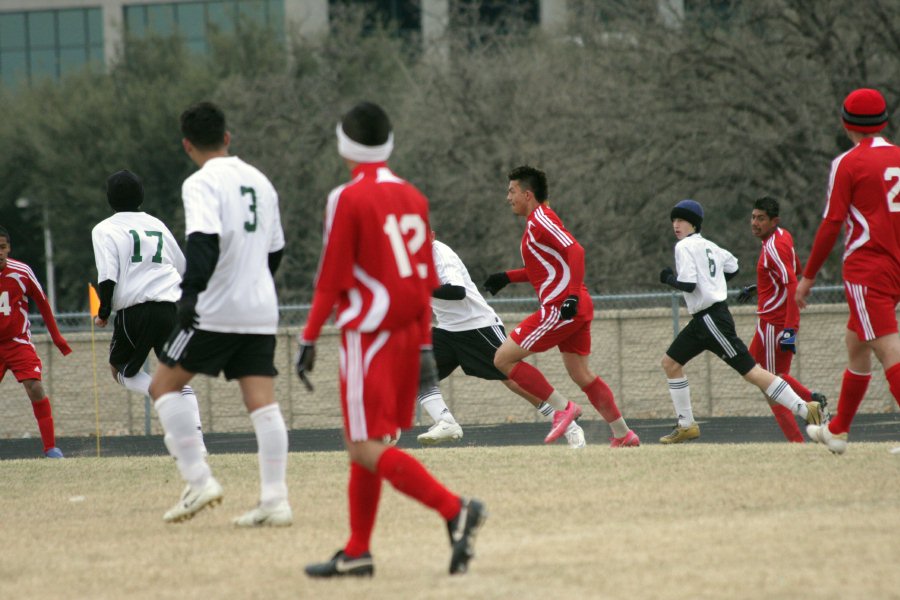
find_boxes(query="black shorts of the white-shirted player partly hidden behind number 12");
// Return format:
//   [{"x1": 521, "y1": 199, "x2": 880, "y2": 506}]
[{"x1": 431, "y1": 325, "x2": 507, "y2": 381}]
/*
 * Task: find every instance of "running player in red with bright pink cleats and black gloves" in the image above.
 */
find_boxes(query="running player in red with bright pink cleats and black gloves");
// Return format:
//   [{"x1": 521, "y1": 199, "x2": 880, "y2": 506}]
[{"x1": 484, "y1": 166, "x2": 640, "y2": 448}]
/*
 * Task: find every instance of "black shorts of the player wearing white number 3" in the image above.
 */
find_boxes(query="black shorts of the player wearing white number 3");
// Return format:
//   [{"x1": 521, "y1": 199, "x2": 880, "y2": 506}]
[{"x1": 159, "y1": 327, "x2": 278, "y2": 379}]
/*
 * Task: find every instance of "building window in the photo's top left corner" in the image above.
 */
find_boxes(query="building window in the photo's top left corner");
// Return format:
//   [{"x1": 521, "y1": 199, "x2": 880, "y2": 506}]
[{"x1": 0, "y1": 8, "x2": 103, "y2": 87}]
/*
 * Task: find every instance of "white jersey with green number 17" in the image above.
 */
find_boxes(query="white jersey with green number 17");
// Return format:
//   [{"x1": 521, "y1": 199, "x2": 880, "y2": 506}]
[{"x1": 91, "y1": 212, "x2": 184, "y2": 310}]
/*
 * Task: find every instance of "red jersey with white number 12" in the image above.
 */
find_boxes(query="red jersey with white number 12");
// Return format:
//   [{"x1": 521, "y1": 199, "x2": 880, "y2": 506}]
[{"x1": 303, "y1": 163, "x2": 439, "y2": 342}]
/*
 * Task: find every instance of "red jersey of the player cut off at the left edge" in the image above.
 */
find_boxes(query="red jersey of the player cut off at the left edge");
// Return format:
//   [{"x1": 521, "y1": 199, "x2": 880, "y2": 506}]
[{"x1": 0, "y1": 258, "x2": 59, "y2": 344}]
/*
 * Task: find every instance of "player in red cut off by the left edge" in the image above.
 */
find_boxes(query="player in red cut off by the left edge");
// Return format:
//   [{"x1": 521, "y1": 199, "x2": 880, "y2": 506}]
[{"x1": 0, "y1": 227, "x2": 72, "y2": 458}]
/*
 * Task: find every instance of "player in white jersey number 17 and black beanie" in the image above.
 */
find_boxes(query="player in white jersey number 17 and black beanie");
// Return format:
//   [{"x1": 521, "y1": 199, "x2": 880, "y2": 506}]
[{"x1": 91, "y1": 171, "x2": 203, "y2": 458}]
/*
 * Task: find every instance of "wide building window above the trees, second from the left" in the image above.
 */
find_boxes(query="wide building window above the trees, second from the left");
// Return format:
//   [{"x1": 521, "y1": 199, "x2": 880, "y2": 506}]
[{"x1": 125, "y1": 0, "x2": 284, "y2": 52}]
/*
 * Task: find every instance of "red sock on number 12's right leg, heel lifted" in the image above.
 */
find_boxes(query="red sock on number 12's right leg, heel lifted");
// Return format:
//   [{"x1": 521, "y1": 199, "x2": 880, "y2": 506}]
[{"x1": 376, "y1": 446, "x2": 461, "y2": 521}]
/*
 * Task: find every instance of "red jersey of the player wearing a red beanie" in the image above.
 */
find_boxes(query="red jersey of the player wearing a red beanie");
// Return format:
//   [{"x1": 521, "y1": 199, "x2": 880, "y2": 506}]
[{"x1": 824, "y1": 137, "x2": 900, "y2": 293}]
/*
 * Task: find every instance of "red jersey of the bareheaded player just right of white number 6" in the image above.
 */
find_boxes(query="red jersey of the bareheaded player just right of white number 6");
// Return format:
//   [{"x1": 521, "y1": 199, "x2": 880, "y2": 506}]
[{"x1": 756, "y1": 227, "x2": 801, "y2": 329}]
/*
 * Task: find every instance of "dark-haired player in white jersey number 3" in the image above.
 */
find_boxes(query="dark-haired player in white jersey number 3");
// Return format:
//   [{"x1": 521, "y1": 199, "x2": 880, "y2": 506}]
[{"x1": 150, "y1": 102, "x2": 293, "y2": 527}]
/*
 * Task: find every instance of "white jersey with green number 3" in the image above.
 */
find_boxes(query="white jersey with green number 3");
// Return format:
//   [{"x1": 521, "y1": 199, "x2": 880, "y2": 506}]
[{"x1": 181, "y1": 156, "x2": 284, "y2": 334}]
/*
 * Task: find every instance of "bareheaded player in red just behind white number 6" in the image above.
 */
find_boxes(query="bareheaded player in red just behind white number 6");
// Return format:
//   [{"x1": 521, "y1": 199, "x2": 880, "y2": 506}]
[{"x1": 738, "y1": 196, "x2": 826, "y2": 443}]
